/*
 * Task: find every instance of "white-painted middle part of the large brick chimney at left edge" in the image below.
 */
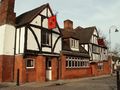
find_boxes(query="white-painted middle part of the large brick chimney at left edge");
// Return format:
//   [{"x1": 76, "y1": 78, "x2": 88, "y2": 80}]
[{"x1": 0, "y1": 24, "x2": 15, "y2": 55}]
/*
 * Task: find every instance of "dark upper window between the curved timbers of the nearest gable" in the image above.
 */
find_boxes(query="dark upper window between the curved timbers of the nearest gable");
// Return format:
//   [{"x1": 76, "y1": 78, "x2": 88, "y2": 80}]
[{"x1": 42, "y1": 31, "x2": 51, "y2": 46}]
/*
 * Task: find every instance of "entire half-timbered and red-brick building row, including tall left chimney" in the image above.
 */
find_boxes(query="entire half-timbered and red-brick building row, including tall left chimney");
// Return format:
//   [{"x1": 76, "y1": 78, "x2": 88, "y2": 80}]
[{"x1": 0, "y1": 0, "x2": 111, "y2": 84}]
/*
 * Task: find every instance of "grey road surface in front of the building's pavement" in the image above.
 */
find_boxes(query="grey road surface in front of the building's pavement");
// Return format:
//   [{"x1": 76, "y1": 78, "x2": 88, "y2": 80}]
[{"x1": 0, "y1": 76, "x2": 117, "y2": 90}]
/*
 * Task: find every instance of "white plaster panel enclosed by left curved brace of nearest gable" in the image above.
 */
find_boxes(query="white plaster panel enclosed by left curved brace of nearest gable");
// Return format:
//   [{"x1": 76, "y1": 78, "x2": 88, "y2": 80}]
[{"x1": 27, "y1": 30, "x2": 39, "y2": 51}]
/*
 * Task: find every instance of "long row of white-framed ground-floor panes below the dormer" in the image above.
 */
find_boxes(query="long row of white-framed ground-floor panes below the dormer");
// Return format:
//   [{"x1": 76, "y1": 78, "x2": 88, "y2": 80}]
[{"x1": 66, "y1": 56, "x2": 89, "y2": 68}]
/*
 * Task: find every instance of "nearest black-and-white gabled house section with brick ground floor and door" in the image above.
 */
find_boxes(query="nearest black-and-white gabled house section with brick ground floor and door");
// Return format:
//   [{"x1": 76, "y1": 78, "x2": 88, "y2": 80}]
[{"x1": 15, "y1": 4, "x2": 62, "y2": 83}]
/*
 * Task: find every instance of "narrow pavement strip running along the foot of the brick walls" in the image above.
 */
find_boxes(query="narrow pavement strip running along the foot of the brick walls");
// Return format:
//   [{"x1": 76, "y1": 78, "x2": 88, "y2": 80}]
[{"x1": 0, "y1": 75, "x2": 115, "y2": 88}]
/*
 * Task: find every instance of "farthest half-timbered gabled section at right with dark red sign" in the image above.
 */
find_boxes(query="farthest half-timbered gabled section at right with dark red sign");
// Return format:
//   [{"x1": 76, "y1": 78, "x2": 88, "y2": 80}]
[{"x1": 75, "y1": 27, "x2": 111, "y2": 76}]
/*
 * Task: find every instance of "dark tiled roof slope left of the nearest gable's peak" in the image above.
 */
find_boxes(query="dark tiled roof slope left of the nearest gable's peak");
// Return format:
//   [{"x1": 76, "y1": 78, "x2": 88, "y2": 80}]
[{"x1": 16, "y1": 4, "x2": 48, "y2": 26}]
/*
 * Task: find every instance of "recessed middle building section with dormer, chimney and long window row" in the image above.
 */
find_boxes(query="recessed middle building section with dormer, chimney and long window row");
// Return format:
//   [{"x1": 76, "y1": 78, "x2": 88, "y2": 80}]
[{"x1": 61, "y1": 20, "x2": 91, "y2": 79}]
